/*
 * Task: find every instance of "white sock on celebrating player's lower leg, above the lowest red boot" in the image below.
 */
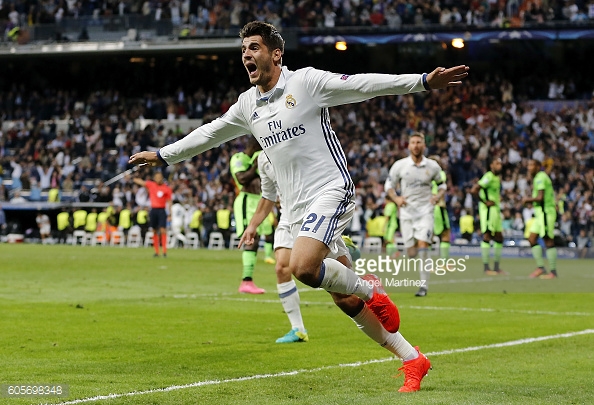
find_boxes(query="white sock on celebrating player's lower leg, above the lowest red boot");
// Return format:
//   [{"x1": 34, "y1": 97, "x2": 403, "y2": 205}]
[{"x1": 352, "y1": 306, "x2": 419, "y2": 361}]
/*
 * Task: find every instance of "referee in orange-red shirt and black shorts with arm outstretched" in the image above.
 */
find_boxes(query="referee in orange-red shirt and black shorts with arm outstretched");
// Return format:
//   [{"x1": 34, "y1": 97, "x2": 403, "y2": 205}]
[{"x1": 133, "y1": 172, "x2": 172, "y2": 257}]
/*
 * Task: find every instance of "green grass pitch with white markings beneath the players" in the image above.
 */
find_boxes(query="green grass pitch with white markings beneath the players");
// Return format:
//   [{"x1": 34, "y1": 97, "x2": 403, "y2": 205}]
[{"x1": 0, "y1": 245, "x2": 594, "y2": 405}]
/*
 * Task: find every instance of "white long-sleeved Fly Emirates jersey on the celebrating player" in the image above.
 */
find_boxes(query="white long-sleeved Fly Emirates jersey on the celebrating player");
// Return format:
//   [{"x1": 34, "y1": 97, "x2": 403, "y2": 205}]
[{"x1": 159, "y1": 67, "x2": 425, "y2": 223}]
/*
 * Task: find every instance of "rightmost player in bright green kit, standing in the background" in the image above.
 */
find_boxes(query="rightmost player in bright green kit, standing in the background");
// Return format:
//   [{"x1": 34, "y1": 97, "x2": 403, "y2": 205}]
[{"x1": 522, "y1": 158, "x2": 557, "y2": 279}]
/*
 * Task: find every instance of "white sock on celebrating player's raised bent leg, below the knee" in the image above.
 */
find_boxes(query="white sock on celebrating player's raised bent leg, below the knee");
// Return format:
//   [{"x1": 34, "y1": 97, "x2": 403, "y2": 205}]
[{"x1": 318, "y1": 258, "x2": 373, "y2": 301}]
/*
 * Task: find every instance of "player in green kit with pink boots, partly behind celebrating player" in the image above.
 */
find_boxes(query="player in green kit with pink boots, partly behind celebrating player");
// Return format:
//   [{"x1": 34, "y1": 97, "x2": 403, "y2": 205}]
[{"x1": 229, "y1": 137, "x2": 266, "y2": 294}]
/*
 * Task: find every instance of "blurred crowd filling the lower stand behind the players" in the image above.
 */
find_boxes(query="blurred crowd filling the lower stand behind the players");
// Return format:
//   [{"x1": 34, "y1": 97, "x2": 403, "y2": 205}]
[{"x1": 0, "y1": 68, "x2": 594, "y2": 248}]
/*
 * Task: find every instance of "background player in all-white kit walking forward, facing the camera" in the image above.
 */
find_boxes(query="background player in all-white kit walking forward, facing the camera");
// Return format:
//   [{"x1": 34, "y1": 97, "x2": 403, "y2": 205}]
[{"x1": 385, "y1": 132, "x2": 446, "y2": 297}]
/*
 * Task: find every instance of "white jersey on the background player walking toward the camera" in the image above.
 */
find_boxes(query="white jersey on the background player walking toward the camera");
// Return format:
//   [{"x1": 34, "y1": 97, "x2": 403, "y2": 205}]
[{"x1": 384, "y1": 156, "x2": 445, "y2": 220}]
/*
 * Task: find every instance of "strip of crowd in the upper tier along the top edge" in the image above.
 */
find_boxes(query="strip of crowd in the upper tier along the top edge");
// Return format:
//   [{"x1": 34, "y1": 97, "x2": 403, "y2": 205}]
[{"x1": 0, "y1": 0, "x2": 594, "y2": 42}]
